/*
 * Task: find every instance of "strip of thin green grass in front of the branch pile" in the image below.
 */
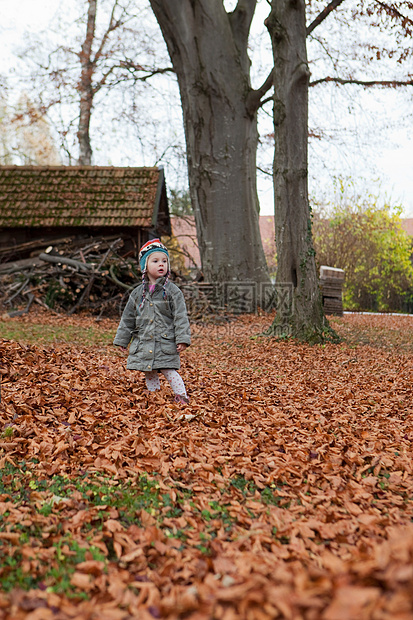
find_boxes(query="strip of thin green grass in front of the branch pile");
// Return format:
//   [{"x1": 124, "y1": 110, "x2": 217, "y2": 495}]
[{"x1": 0, "y1": 321, "x2": 115, "y2": 346}]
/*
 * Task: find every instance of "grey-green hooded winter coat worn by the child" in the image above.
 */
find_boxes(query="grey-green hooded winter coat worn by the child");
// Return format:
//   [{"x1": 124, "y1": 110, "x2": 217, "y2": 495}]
[{"x1": 113, "y1": 278, "x2": 191, "y2": 372}]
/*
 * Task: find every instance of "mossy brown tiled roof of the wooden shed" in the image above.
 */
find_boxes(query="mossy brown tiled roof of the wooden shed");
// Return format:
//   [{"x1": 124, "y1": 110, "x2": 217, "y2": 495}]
[{"x1": 0, "y1": 166, "x2": 166, "y2": 228}]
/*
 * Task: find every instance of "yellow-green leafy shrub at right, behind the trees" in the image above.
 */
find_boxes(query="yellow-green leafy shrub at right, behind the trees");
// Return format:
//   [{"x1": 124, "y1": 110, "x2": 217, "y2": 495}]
[{"x1": 313, "y1": 183, "x2": 413, "y2": 311}]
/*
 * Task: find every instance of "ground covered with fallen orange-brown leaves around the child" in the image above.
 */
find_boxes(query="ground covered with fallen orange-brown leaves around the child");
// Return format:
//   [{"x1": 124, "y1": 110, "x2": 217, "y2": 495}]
[{"x1": 0, "y1": 315, "x2": 413, "y2": 620}]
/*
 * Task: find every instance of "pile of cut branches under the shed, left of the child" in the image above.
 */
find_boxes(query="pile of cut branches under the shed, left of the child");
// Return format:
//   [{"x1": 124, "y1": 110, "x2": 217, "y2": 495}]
[{"x1": 0, "y1": 236, "x2": 140, "y2": 316}]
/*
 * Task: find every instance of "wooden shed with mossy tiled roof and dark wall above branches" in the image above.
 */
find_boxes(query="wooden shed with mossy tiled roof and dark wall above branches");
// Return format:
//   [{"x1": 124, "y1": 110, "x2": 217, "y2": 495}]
[{"x1": 0, "y1": 166, "x2": 171, "y2": 255}]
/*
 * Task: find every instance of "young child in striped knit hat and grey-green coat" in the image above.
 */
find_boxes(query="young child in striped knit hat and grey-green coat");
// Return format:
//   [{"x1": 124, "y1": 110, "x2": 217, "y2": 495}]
[{"x1": 113, "y1": 239, "x2": 191, "y2": 403}]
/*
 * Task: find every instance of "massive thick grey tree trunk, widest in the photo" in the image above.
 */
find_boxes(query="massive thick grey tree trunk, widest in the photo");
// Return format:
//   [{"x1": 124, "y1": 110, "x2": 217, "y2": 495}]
[{"x1": 150, "y1": 0, "x2": 269, "y2": 282}]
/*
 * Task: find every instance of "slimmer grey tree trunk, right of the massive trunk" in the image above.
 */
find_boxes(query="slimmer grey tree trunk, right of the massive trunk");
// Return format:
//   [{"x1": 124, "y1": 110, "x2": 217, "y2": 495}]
[{"x1": 266, "y1": 0, "x2": 332, "y2": 342}]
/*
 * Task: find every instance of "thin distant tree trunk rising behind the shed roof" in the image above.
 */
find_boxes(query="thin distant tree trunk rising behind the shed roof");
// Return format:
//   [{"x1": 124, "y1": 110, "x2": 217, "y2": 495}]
[{"x1": 77, "y1": 0, "x2": 97, "y2": 166}]
